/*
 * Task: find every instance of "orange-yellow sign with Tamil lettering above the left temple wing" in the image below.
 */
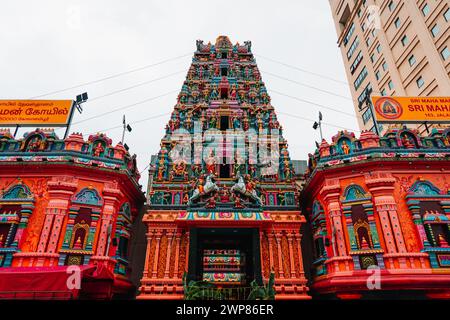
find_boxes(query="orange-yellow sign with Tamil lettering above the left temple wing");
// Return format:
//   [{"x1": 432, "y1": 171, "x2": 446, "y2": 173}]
[{"x1": 0, "y1": 100, "x2": 74, "y2": 126}]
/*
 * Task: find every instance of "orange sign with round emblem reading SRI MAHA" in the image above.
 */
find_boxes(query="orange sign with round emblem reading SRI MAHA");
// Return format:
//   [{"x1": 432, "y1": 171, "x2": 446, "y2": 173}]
[{"x1": 372, "y1": 97, "x2": 450, "y2": 123}]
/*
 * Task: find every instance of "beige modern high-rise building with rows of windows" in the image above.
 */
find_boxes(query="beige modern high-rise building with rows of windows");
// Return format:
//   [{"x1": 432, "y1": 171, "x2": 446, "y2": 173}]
[{"x1": 329, "y1": 0, "x2": 450, "y2": 132}]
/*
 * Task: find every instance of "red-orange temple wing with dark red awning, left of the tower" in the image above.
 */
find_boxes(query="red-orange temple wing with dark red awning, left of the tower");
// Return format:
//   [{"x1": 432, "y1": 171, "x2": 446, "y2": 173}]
[{"x1": 0, "y1": 129, "x2": 145, "y2": 299}]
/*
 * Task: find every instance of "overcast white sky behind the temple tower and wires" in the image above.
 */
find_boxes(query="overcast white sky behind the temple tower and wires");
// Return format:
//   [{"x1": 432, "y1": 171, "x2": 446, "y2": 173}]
[{"x1": 0, "y1": 0, "x2": 358, "y2": 186}]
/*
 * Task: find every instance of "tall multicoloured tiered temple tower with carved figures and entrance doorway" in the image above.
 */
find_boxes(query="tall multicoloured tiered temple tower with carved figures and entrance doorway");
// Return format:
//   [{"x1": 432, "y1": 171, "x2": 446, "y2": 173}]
[{"x1": 138, "y1": 36, "x2": 309, "y2": 299}]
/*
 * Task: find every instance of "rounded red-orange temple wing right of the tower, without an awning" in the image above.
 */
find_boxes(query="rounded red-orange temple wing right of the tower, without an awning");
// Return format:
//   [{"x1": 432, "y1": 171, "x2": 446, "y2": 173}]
[{"x1": 301, "y1": 128, "x2": 450, "y2": 298}]
